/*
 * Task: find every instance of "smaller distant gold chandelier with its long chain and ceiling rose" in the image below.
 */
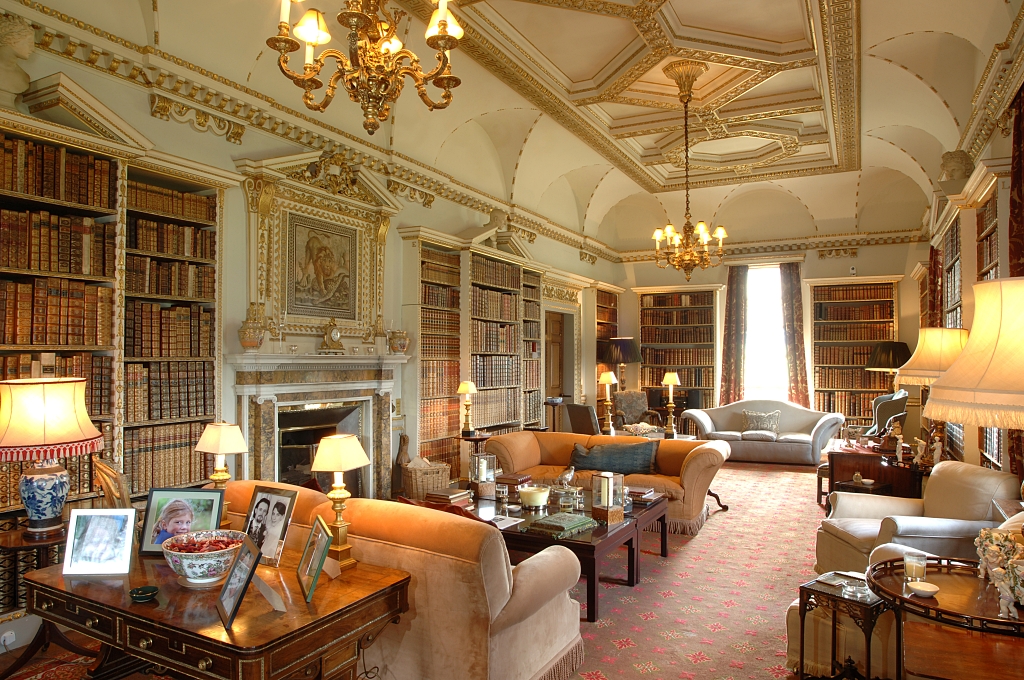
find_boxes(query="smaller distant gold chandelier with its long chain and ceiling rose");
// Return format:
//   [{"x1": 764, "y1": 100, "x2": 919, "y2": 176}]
[{"x1": 651, "y1": 59, "x2": 729, "y2": 281}]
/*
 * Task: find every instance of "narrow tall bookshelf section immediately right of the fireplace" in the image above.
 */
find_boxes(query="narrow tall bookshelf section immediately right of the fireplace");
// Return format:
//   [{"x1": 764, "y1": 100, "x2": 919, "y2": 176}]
[{"x1": 419, "y1": 242, "x2": 462, "y2": 479}]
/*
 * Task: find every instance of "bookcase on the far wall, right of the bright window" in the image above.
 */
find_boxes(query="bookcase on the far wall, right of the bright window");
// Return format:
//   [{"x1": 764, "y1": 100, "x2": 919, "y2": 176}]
[{"x1": 806, "y1": 277, "x2": 899, "y2": 425}]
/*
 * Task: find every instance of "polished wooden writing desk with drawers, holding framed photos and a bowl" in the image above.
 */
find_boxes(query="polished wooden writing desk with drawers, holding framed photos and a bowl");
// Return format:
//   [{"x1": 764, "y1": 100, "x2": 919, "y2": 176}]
[{"x1": 15, "y1": 552, "x2": 410, "y2": 680}]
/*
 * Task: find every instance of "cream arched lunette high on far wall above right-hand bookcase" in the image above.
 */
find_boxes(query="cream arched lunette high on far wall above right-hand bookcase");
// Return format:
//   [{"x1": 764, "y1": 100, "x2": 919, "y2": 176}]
[{"x1": 857, "y1": 167, "x2": 928, "y2": 231}]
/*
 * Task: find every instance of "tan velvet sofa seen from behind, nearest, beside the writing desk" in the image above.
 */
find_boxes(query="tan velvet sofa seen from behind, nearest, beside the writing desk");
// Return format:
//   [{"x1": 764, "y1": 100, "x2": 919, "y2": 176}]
[{"x1": 224, "y1": 480, "x2": 584, "y2": 680}]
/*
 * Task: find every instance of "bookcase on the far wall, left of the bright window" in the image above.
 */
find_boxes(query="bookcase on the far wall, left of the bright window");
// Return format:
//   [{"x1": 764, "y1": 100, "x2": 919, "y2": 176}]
[{"x1": 634, "y1": 288, "x2": 721, "y2": 434}]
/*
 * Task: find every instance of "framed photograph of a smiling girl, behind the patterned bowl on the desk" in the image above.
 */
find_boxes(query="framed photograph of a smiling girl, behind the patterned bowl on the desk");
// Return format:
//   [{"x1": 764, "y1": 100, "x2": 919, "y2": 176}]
[{"x1": 139, "y1": 488, "x2": 224, "y2": 555}]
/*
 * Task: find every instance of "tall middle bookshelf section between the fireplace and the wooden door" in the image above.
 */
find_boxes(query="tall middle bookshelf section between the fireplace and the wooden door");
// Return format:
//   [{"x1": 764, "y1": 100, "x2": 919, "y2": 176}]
[{"x1": 463, "y1": 250, "x2": 524, "y2": 434}]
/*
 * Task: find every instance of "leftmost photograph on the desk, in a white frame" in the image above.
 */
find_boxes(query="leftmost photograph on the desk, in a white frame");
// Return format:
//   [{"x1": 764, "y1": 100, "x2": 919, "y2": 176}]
[{"x1": 63, "y1": 508, "x2": 135, "y2": 575}]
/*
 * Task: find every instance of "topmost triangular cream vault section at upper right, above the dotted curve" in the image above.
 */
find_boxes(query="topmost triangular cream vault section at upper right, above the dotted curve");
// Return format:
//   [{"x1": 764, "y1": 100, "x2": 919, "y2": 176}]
[{"x1": 868, "y1": 32, "x2": 988, "y2": 126}]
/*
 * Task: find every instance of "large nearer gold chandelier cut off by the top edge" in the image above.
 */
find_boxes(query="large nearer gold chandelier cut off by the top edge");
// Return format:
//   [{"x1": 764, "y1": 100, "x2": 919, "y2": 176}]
[{"x1": 266, "y1": 0, "x2": 465, "y2": 134}]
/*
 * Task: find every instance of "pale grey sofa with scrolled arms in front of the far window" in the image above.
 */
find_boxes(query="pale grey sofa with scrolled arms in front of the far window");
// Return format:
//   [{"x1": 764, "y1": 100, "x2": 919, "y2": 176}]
[{"x1": 683, "y1": 399, "x2": 846, "y2": 465}]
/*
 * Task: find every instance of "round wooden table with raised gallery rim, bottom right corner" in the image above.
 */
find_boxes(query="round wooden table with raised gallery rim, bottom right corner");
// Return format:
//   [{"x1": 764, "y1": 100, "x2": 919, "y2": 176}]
[{"x1": 867, "y1": 557, "x2": 1024, "y2": 680}]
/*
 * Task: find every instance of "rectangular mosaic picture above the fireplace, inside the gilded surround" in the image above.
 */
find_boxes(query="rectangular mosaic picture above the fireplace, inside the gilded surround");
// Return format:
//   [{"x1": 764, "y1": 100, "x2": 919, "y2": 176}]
[{"x1": 287, "y1": 212, "x2": 359, "y2": 320}]
